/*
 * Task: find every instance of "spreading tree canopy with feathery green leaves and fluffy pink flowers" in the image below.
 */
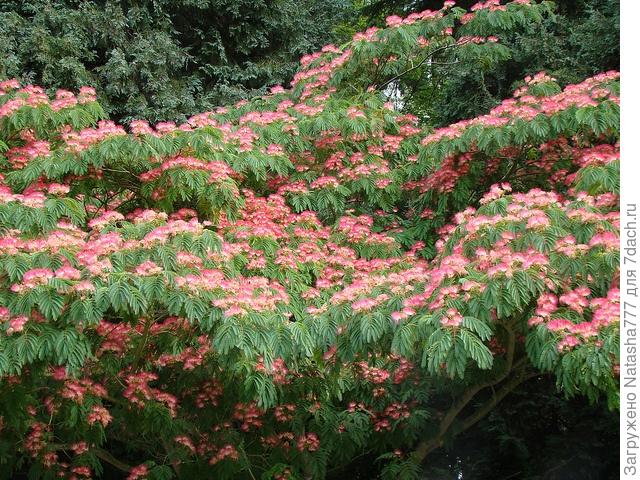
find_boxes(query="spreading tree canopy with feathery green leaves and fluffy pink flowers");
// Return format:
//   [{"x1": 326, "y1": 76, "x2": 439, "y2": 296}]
[{"x1": 0, "y1": 0, "x2": 619, "y2": 480}]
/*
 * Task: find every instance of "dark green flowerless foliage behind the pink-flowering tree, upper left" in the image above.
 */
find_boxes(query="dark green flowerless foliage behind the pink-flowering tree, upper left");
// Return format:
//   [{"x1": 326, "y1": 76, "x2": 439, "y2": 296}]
[{"x1": 0, "y1": 0, "x2": 356, "y2": 122}]
